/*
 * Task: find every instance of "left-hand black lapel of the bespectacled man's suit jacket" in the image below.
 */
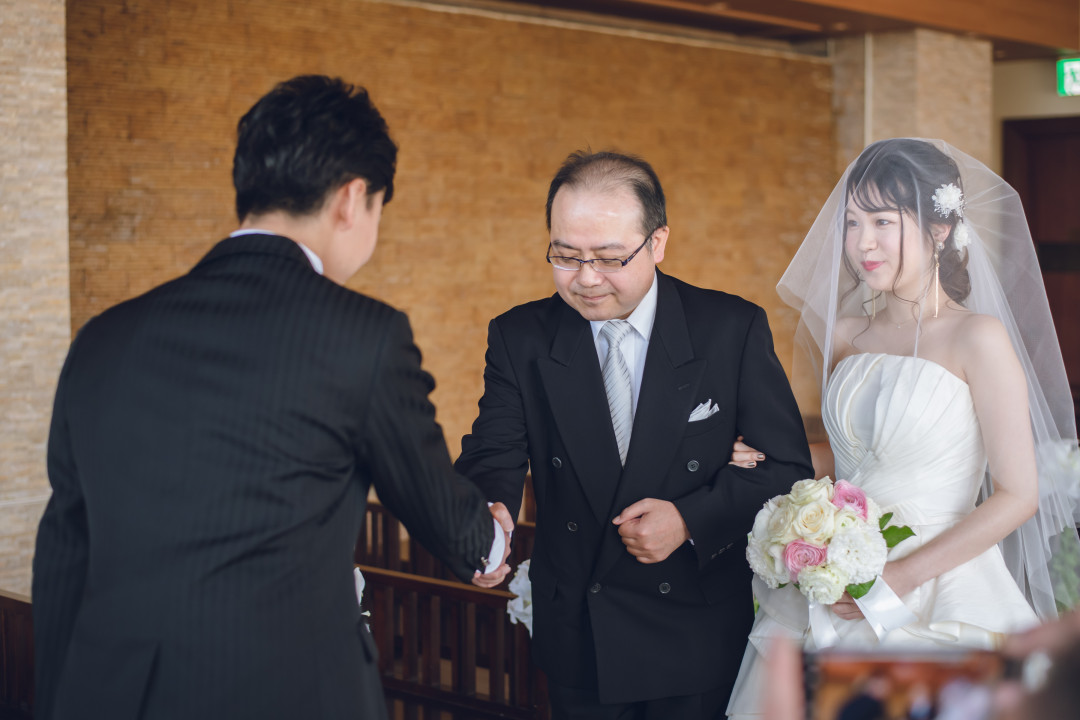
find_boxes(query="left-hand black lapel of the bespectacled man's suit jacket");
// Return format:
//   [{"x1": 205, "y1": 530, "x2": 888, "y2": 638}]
[{"x1": 538, "y1": 303, "x2": 622, "y2": 524}]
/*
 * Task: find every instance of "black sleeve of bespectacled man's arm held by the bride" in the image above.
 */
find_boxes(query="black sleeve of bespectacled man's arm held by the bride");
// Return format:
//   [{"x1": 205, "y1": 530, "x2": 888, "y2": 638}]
[{"x1": 675, "y1": 308, "x2": 813, "y2": 567}]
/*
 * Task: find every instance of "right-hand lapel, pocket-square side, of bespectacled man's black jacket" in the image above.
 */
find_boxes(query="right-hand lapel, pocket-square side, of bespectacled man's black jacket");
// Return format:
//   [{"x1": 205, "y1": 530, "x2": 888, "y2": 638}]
[{"x1": 596, "y1": 273, "x2": 706, "y2": 576}]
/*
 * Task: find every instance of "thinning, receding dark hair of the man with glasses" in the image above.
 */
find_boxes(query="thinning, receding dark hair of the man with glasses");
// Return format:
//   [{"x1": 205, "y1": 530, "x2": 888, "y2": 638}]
[{"x1": 546, "y1": 150, "x2": 667, "y2": 234}]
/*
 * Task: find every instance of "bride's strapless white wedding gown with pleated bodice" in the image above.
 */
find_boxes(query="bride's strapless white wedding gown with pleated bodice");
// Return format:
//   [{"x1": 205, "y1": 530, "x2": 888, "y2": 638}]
[{"x1": 728, "y1": 354, "x2": 1038, "y2": 718}]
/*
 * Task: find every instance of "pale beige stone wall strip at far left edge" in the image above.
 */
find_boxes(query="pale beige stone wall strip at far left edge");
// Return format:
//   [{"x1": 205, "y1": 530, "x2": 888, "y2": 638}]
[{"x1": 0, "y1": 0, "x2": 70, "y2": 594}]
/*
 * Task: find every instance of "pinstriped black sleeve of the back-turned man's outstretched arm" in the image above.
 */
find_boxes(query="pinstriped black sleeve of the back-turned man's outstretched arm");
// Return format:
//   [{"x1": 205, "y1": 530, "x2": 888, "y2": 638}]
[{"x1": 364, "y1": 313, "x2": 494, "y2": 581}]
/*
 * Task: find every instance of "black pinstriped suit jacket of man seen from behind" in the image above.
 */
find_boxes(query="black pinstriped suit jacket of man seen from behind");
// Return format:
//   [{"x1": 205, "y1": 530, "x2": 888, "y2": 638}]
[{"x1": 33, "y1": 235, "x2": 492, "y2": 720}]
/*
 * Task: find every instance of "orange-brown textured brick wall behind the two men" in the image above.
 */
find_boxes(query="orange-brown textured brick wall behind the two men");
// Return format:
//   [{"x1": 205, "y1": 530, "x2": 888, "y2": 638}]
[{"x1": 68, "y1": 0, "x2": 835, "y2": 452}]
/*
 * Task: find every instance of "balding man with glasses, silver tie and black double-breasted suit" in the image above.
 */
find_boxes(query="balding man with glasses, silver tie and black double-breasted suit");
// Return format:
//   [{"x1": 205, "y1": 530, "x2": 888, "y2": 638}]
[{"x1": 456, "y1": 148, "x2": 813, "y2": 720}]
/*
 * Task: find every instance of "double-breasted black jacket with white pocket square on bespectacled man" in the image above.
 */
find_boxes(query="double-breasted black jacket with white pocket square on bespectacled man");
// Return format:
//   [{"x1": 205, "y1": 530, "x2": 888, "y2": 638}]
[{"x1": 456, "y1": 272, "x2": 813, "y2": 703}]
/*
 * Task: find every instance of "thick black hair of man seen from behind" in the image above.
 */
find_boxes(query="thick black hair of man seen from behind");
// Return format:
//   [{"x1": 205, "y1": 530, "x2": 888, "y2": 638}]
[{"x1": 232, "y1": 76, "x2": 397, "y2": 221}]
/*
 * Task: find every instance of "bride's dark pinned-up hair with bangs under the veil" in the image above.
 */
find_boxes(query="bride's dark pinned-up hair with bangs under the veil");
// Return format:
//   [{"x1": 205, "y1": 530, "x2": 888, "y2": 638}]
[{"x1": 843, "y1": 138, "x2": 971, "y2": 303}]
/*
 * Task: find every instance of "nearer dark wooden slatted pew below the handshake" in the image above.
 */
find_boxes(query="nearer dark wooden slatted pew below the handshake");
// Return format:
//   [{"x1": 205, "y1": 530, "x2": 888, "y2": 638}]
[{"x1": 357, "y1": 566, "x2": 548, "y2": 720}]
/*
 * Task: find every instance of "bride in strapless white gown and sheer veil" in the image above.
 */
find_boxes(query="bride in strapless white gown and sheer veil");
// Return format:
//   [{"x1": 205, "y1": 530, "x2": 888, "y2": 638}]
[{"x1": 728, "y1": 139, "x2": 1080, "y2": 717}]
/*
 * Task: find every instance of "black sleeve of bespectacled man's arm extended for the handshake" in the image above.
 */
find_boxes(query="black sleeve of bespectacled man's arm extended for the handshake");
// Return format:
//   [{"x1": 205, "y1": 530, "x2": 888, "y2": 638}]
[{"x1": 455, "y1": 320, "x2": 529, "y2": 518}]
